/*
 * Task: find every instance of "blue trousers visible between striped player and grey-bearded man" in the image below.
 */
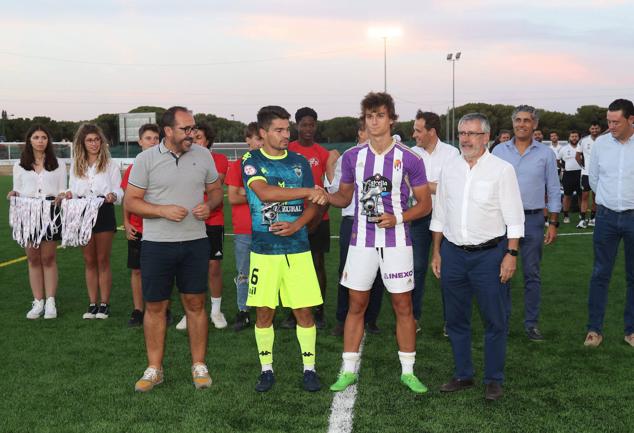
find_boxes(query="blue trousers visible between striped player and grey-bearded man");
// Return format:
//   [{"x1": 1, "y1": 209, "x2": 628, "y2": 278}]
[{"x1": 409, "y1": 214, "x2": 434, "y2": 321}]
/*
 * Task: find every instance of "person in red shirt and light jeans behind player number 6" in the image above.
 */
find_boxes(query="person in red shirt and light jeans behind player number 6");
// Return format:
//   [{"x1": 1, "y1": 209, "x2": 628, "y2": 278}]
[{"x1": 225, "y1": 122, "x2": 262, "y2": 331}]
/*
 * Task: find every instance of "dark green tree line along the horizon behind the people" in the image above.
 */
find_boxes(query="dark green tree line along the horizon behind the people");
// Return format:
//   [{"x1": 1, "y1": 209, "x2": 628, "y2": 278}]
[{"x1": 0, "y1": 103, "x2": 607, "y2": 146}]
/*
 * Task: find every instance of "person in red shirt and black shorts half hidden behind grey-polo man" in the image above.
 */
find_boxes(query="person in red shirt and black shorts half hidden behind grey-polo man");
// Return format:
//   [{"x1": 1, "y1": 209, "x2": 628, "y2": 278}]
[{"x1": 176, "y1": 123, "x2": 229, "y2": 331}]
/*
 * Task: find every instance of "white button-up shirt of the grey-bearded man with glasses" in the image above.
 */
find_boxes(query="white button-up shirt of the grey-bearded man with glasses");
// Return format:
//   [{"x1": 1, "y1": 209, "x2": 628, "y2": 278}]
[{"x1": 429, "y1": 150, "x2": 524, "y2": 245}]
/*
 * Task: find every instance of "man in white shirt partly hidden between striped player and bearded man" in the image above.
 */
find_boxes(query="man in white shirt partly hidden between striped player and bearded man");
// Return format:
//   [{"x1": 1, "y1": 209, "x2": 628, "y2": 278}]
[{"x1": 410, "y1": 110, "x2": 458, "y2": 331}]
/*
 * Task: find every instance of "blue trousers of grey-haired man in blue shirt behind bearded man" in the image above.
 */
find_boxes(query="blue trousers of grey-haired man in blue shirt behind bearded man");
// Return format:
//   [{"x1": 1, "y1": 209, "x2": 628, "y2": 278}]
[{"x1": 507, "y1": 212, "x2": 544, "y2": 329}]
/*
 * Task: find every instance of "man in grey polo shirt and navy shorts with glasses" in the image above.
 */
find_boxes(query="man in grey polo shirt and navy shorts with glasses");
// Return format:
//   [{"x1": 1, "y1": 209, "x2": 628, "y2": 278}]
[{"x1": 125, "y1": 107, "x2": 223, "y2": 392}]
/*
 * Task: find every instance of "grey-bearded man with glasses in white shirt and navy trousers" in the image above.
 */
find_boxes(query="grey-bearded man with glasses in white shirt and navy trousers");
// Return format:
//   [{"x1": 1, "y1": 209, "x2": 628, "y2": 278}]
[{"x1": 430, "y1": 113, "x2": 524, "y2": 400}]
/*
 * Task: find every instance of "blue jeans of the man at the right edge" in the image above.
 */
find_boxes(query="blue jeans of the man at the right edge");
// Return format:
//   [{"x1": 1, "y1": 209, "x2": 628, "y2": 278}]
[{"x1": 588, "y1": 205, "x2": 634, "y2": 335}]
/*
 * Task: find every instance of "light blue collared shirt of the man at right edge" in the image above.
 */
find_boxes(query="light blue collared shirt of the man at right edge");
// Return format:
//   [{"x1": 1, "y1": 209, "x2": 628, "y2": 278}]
[{"x1": 588, "y1": 133, "x2": 634, "y2": 212}]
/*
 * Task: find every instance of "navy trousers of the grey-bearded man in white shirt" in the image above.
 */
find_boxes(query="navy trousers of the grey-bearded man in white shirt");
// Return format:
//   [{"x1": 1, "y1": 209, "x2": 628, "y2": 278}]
[{"x1": 440, "y1": 240, "x2": 509, "y2": 383}]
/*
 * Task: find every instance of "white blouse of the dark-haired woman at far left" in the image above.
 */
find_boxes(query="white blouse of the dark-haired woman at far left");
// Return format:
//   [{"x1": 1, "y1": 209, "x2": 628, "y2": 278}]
[{"x1": 13, "y1": 159, "x2": 66, "y2": 198}]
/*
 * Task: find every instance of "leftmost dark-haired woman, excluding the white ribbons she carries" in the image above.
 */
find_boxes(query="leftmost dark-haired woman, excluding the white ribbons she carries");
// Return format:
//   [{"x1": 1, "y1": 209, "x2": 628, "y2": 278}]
[{"x1": 7, "y1": 125, "x2": 66, "y2": 319}]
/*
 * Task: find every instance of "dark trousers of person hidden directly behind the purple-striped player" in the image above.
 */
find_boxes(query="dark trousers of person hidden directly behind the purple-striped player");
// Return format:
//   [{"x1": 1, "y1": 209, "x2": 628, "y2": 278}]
[{"x1": 336, "y1": 217, "x2": 385, "y2": 323}]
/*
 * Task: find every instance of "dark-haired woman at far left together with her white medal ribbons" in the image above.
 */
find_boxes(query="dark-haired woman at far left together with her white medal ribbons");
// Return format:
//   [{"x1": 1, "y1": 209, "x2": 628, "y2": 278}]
[{"x1": 7, "y1": 125, "x2": 66, "y2": 319}]
